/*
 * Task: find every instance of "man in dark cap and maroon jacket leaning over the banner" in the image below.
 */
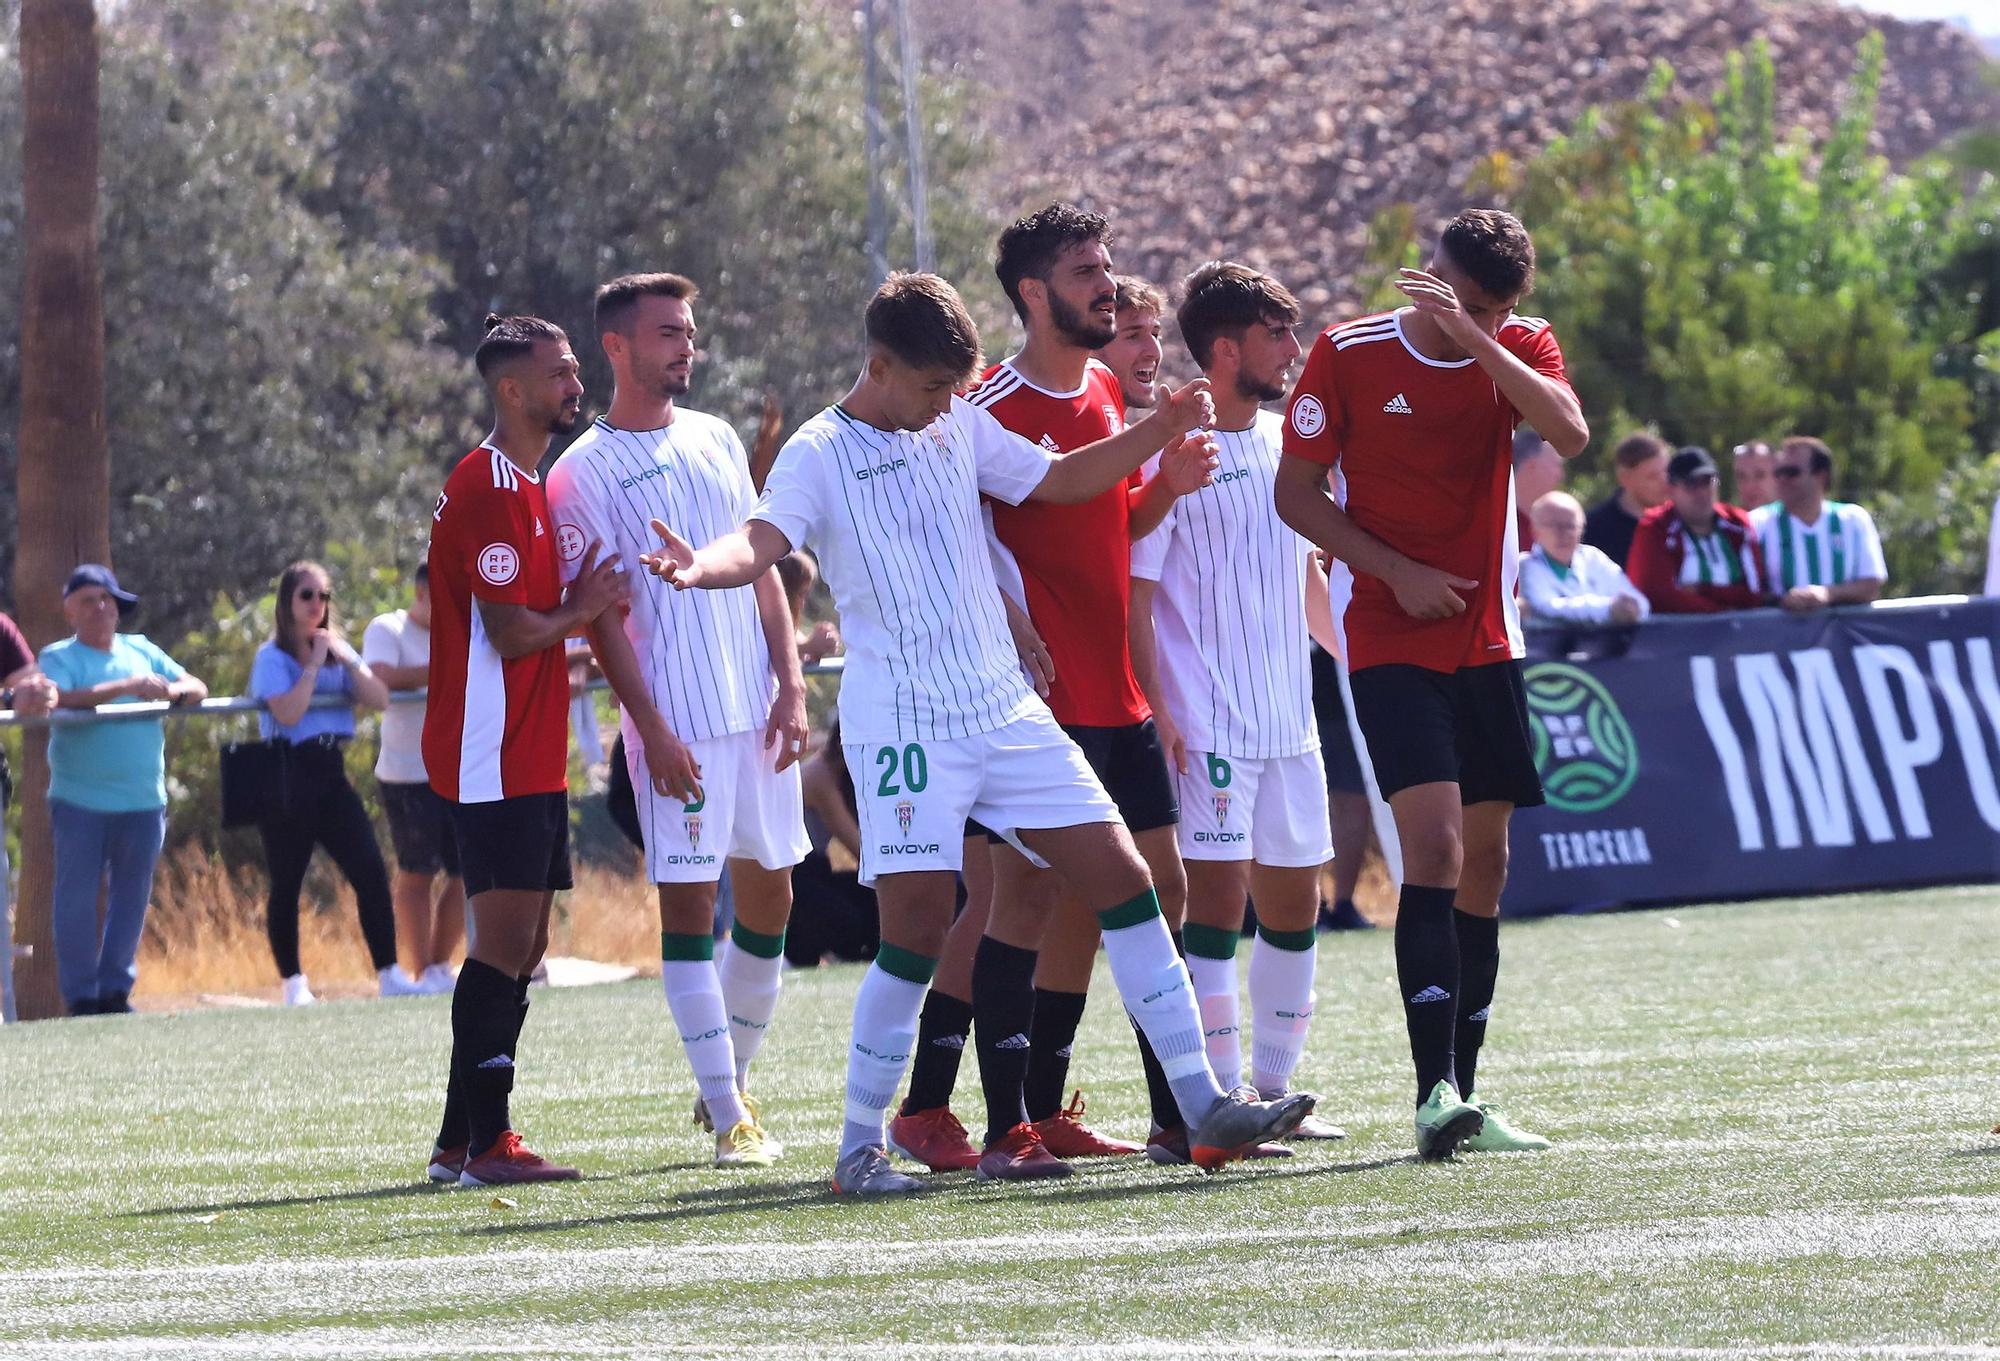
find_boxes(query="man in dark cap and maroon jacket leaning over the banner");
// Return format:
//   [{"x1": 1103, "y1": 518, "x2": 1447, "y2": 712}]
[{"x1": 1626, "y1": 446, "x2": 1770, "y2": 614}]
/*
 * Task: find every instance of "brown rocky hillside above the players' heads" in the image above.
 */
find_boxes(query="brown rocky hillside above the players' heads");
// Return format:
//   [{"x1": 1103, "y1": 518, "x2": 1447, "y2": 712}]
[{"x1": 916, "y1": 0, "x2": 2000, "y2": 316}]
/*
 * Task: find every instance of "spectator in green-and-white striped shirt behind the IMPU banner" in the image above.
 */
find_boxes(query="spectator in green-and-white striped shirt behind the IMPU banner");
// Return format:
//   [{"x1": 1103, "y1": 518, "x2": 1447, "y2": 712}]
[{"x1": 1750, "y1": 434, "x2": 1888, "y2": 612}]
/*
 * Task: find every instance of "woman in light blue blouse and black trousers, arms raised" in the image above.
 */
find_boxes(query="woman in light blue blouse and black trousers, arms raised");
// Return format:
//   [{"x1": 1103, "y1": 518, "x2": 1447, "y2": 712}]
[{"x1": 250, "y1": 562, "x2": 408, "y2": 1007}]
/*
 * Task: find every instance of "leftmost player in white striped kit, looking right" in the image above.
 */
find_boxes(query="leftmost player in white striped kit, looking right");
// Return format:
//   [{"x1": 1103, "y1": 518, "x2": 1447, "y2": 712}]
[{"x1": 548, "y1": 274, "x2": 812, "y2": 1167}]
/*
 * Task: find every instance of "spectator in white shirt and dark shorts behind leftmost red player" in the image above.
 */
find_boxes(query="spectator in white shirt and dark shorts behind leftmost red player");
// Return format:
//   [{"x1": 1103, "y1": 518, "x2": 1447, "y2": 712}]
[{"x1": 362, "y1": 562, "x2": 466, "y2": 993}]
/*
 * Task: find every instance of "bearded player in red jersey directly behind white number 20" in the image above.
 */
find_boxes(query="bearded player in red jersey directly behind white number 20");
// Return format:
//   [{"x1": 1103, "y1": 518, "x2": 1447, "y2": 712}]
[{"x1": 916, "y1": 202, "x2": 1186, "y2": 1157}]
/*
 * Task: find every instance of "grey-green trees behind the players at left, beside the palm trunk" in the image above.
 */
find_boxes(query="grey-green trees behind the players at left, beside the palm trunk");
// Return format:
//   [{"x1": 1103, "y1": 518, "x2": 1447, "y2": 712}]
[{"x1": 0, "y1": 0, "x2": 992, "y2": 644}]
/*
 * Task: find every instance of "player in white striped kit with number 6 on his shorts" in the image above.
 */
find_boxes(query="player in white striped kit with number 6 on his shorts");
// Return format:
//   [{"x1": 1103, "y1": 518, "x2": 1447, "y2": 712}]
[{"x1": 1132, "y1": 260, "x2": 1346, "y2": 1139}]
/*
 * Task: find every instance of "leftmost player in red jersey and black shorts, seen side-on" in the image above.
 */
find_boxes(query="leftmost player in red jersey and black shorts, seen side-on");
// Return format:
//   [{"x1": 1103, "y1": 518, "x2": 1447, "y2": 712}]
[{"x1": 424, "y1": 316, "x2": 626, "y2": 1187}]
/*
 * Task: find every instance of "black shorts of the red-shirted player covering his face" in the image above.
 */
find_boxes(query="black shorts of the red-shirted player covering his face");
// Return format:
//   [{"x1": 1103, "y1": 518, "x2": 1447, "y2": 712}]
[{"x1": 1348, "y1": 660, "x2": 1542, "y2": 809}]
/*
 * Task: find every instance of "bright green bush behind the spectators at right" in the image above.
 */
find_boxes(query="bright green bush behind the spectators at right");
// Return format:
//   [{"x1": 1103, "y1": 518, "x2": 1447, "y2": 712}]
[{"x1": 1520, "y1": 34, "x2": 2000, "y2": 594}]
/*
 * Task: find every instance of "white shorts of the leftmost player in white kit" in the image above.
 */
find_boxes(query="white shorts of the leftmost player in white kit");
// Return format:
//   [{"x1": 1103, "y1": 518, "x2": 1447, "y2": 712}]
[{"x1": 624, "y1": 725, "x2": 812, "y2": 885}]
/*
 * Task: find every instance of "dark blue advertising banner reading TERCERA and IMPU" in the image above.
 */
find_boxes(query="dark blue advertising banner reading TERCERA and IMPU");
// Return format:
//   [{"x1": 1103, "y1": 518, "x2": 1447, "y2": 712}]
[{"x1": 1502, "y1": 596, "x2": 2000, "y2": 915}]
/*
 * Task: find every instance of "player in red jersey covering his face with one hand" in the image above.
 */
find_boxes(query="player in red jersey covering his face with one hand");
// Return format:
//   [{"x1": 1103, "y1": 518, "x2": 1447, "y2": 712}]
[{"x1": 1274, "y1": 210, "x2": 1590, "y2": 1159}]
